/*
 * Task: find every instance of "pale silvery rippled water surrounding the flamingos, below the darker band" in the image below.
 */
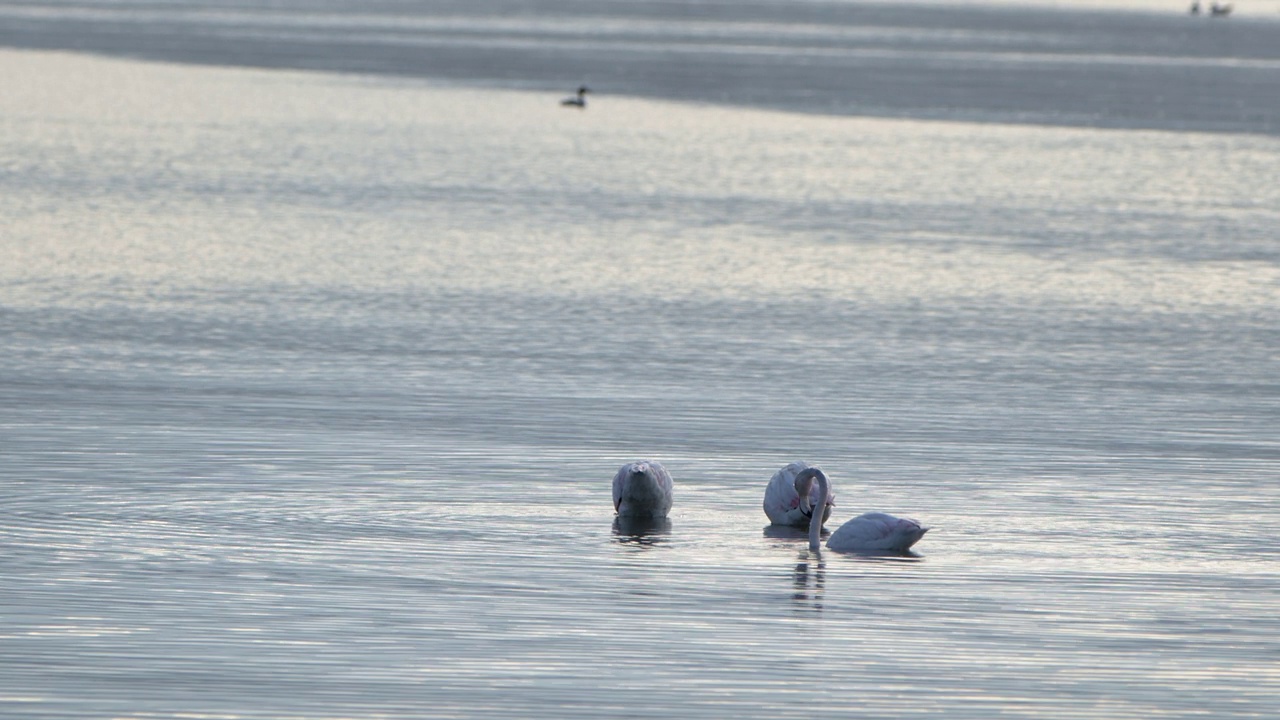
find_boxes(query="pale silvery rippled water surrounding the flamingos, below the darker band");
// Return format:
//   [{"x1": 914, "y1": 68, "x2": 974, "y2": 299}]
[{"x1": 0, "y1": 4, "x2": 1280, "y2": 719}]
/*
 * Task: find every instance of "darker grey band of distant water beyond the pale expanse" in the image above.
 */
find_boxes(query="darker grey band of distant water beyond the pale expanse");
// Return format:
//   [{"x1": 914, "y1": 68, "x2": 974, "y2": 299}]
[{"x1": 0, "y1": 0, "x2": 1280, "y2": 133}]
